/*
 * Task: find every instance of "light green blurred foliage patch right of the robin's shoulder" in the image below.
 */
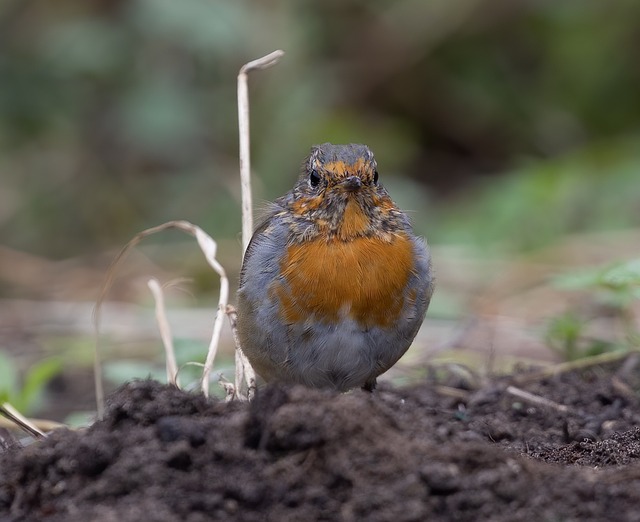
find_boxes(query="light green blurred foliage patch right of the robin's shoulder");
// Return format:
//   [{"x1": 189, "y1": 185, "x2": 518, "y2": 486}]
[{"x1": 430, "y1": 137, "x2": 640, "y2": 249}]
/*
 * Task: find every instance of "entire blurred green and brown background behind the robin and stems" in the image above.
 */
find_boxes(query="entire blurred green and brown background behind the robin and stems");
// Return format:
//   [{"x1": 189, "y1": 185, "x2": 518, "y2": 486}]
[{"x1": 0, "y1": 0, "x2": 640, "y2": 419}]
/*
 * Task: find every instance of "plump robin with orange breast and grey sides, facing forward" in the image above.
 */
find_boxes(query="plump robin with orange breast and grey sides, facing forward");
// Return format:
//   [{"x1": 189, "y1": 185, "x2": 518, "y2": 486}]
[{"x1": 237, "y1": 143, "x2": 434, "y2": 391}]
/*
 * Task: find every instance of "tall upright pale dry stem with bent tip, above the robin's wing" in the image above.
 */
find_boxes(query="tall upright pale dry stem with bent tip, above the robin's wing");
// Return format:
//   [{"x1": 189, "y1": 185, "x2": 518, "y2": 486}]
[{"x1": 238, "y1": 50, "x2": 284, "y2": 253}]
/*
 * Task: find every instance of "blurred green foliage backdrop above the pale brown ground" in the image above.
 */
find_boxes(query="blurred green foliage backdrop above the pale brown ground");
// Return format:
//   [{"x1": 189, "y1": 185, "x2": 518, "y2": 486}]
[{"x1": 0, "y1": 0, "x2": 640, "y2": 258}]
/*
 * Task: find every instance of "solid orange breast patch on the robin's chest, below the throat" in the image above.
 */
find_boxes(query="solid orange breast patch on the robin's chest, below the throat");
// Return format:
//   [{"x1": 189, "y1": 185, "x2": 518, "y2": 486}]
[{"x1": 271, "y1": 235, "x2": 413, "y2": 328}]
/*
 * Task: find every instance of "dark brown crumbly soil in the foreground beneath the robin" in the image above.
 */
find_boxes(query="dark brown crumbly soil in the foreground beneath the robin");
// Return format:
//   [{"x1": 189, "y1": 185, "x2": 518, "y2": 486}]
[{"x1": 0, "y1": 356, "x2": 640, "y2": 522}]
